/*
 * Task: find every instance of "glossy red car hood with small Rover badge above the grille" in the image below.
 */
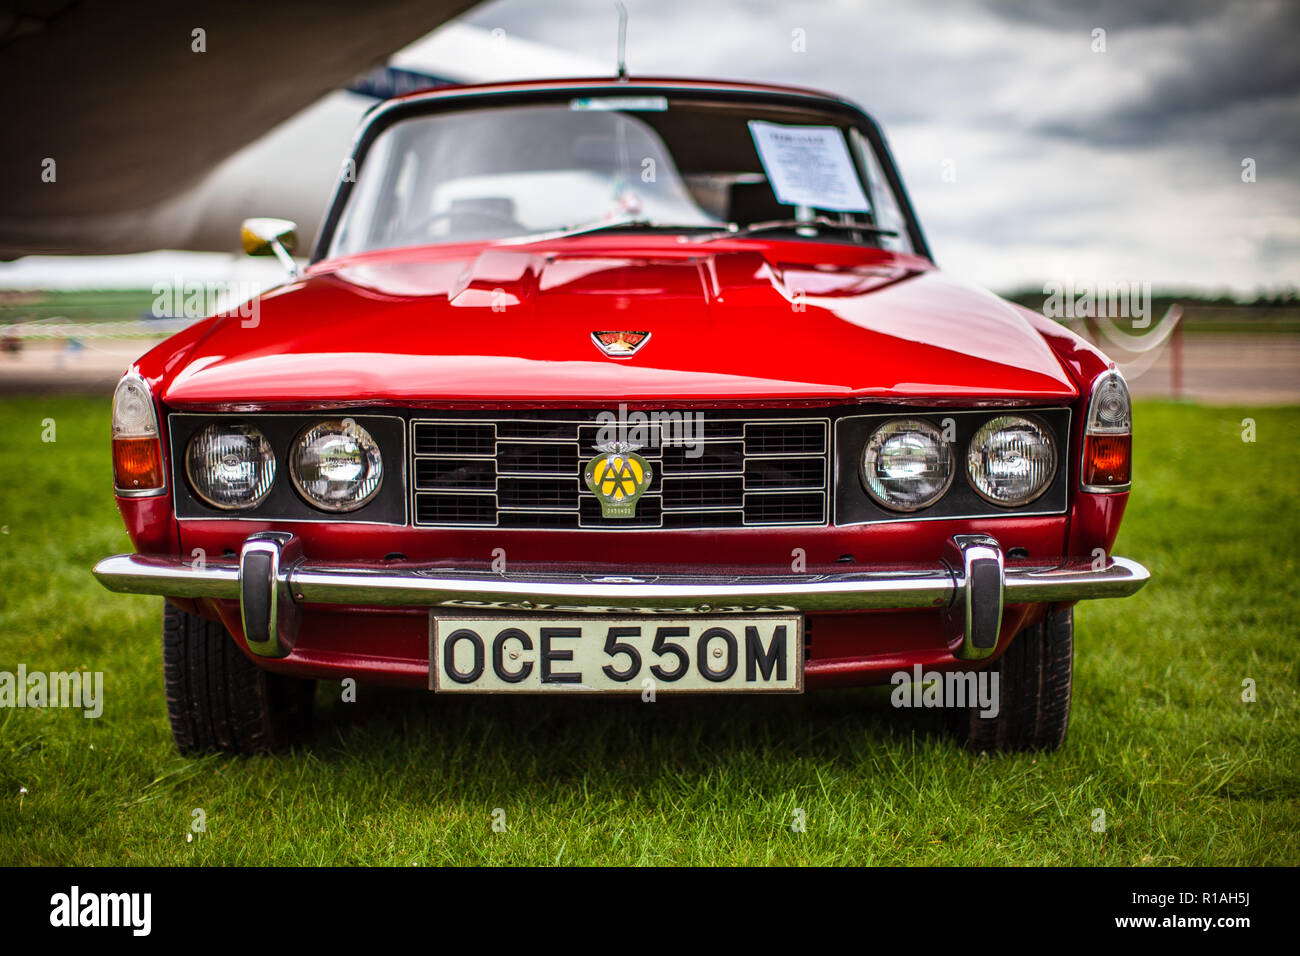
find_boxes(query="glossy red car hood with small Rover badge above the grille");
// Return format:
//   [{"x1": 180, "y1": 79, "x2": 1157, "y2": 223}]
[{"x1": 163, "y1": 241, "x2": 1078, "y2": 407}]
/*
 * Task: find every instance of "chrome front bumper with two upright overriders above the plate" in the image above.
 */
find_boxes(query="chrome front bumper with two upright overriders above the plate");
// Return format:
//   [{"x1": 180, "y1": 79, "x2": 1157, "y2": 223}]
[{"x1": 95, "y1": 532, "x2": 1151, "y2": 659}]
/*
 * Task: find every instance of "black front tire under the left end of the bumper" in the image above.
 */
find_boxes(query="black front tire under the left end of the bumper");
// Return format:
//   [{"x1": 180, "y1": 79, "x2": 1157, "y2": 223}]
[{"x1": 163, "y1": 604, "x2": 316, "y2": 754}]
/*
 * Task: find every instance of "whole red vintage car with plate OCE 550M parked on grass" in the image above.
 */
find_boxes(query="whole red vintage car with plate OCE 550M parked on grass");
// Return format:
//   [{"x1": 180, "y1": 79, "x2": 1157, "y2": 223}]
[{"x1": 95, "y1": 79, "x2": 1148, "y2": 753}]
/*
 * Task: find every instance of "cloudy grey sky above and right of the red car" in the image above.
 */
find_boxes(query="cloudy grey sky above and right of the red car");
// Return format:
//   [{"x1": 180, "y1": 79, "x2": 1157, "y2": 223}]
[{"x1": 463, "y1": 0, "x2": 1300, "y2": 293}]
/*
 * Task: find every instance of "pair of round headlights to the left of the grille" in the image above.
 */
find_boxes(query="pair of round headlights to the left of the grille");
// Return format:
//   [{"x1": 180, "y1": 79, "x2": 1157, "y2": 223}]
[{"x1": 185, "y1": 419, "x2": 384, "y2": 512}]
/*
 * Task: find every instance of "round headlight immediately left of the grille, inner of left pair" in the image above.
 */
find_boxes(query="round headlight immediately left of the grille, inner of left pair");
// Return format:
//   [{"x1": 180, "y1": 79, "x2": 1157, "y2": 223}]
[{"x1": 289, "y1": 419, "x2": 384, "y2": 511}]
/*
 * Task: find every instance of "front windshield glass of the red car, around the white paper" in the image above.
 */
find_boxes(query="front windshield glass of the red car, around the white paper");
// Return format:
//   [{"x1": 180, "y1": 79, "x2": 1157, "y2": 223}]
[{"x1": 328, "y1": 98, "x2": 901, "y2": 255}]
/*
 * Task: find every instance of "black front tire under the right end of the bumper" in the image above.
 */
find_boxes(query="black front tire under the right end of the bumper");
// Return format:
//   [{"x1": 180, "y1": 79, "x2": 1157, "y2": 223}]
[{"x1": 957, "y1": 607, "x2": 1074, "y2": 752}]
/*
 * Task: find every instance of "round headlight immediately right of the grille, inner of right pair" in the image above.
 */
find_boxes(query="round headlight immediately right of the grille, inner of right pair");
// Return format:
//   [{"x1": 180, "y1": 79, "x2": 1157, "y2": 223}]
[{"x1": 862, "y1": 419, "x2": 954, "y2": 511}]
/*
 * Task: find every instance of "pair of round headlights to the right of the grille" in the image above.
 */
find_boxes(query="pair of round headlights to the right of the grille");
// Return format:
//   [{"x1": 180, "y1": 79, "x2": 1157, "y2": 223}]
[{"x1": 862, "y1": 415, "x2": 1057, "y2": 512}]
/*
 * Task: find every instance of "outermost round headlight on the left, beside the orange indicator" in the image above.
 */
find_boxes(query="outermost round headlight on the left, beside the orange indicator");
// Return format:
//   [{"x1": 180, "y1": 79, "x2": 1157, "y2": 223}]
[{"x1": 185, "y1": 423, "x2": 276, "y2": 511}]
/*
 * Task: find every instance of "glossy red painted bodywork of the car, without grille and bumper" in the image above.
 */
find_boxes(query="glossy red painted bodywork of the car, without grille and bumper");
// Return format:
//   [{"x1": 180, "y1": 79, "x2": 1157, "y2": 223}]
[{"x1": 118, "y1": 74, "x2": 1127, "y2": 687}]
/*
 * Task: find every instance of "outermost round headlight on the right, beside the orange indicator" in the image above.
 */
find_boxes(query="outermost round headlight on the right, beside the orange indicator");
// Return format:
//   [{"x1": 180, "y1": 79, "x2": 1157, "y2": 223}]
[{"x1": 966, "y1": 415, "x2": 1057, "y2": 507}]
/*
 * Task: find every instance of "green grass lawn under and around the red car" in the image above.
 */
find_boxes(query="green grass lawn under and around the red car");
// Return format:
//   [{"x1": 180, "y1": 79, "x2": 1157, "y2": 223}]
[{"x1": 0, "y1": 398, "x2": 1300, "y2": 865}]
